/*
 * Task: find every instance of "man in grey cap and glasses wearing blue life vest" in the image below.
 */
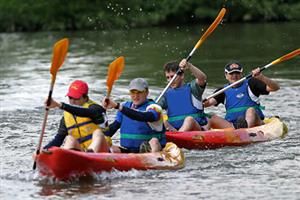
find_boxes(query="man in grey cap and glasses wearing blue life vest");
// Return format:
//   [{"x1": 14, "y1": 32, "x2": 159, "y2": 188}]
[{"x1": 102, "y1": 78, "x2": 166, "y2": 153}]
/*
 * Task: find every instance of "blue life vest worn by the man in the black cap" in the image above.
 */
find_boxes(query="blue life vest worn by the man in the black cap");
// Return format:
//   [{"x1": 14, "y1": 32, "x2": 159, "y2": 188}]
[{"x1": 224, "y1": 80, "x2": 265, "y2": 122}]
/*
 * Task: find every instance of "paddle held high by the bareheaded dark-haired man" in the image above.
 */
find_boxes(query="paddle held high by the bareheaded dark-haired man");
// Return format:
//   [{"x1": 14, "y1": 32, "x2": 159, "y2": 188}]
[{"x1": 156, "y1": 8, "x2": 226, "y2": 102}]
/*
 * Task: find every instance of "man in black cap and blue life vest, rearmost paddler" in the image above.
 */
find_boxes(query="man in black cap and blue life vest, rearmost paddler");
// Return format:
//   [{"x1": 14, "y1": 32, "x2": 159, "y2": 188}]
[{"x1": 204, "y1": 60, "x2": 279, "y2": 128}]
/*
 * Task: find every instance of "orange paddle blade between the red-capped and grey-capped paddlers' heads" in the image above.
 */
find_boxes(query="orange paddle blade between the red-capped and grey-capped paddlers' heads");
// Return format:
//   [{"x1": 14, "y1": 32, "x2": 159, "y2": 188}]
[{"x1": 106, "y1": 56, "x2": 125, "y2": 97}]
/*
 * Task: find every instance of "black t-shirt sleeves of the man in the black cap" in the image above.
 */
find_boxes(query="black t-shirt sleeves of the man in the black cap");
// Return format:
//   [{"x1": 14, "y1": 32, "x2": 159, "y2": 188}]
[{"x1": 214, "y1": 77, "x2": 269, "y2": 106}]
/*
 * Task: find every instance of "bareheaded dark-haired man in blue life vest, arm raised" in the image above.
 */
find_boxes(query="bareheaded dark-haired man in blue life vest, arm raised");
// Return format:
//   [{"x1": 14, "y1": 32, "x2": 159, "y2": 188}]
[{"x1": 158, "y1": 59, "x2": 231, "y2": 131}]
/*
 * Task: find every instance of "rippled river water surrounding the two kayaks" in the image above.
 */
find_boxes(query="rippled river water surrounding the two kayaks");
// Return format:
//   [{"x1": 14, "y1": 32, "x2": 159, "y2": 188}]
[{"x1": 0, "y1": 23, "x2": 300, "y2": 200}]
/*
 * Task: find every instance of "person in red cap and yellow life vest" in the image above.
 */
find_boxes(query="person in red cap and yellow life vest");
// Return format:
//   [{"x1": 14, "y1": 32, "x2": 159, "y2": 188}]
[{"x1": 44, "y1": 80, "x2": 109, "y2": 152}]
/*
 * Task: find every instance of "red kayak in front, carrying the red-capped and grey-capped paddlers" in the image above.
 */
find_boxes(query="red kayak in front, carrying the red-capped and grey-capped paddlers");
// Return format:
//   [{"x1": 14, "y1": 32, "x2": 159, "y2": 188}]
[{"x1": 36, "y1": 142, "x2": 185, "y2": 180}]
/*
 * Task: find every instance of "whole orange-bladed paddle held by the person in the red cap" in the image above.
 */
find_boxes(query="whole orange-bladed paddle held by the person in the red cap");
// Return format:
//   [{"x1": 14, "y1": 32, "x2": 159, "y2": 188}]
[{"x1": 33, "y1": 38, "x2": 69, "y2": 170}]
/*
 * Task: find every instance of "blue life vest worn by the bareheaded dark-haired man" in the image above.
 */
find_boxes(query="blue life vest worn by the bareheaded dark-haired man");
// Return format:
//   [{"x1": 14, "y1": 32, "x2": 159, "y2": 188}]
[{"x1": 165, "y1": 84, "x2": 207, "y2": 129}]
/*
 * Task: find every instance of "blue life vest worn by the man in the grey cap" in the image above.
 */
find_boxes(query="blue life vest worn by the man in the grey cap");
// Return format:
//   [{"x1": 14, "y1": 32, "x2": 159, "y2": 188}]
[{"x1": 120, "y1": 100, "x2": 166, "y2": 151}]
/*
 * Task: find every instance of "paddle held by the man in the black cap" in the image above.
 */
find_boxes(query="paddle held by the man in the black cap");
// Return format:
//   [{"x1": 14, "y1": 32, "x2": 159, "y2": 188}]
[{"x1": 203, "y1": 48, "x2": 300, "y2": 101}]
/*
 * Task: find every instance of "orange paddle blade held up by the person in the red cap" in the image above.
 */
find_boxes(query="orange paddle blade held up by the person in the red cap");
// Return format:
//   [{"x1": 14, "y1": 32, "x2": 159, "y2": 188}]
[{"x1": 50, "y1": 38, "x2": 69, "y2": 80}]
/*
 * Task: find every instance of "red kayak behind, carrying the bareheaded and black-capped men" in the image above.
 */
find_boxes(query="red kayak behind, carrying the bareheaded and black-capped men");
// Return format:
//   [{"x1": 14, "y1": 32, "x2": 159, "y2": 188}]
[{"x1": 166, "y1": 117, "x2": 288, "y2": 149}]
